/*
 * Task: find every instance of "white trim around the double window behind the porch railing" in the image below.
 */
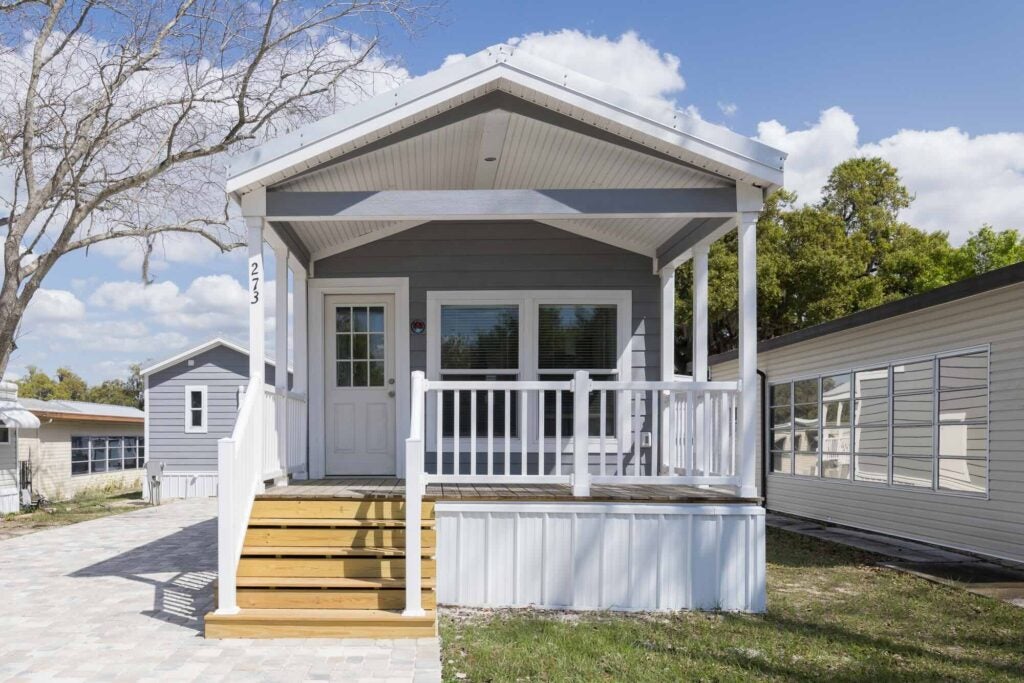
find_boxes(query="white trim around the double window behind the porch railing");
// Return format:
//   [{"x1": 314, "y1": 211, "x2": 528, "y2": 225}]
[{"x1": 426, "y1": 290, "x2": 633, "y2": 453}]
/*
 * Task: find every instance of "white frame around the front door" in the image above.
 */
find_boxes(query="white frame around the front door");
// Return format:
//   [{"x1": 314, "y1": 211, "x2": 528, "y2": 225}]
[{"x1": 307, "y1": 278, "x2": 410, "y2": 479}]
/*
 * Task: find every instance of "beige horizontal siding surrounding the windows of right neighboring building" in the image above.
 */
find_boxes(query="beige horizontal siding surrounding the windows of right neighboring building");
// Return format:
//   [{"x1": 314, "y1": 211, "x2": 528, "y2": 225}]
[{"x1": 713, "y1": 284, "x2": 1024, "y2": 561}]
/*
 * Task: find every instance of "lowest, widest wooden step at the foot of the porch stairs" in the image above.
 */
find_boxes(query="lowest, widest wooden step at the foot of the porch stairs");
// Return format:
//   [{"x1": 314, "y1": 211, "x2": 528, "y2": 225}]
[{"x1": 206, "y1": 609, "x2": 437, "y2": 638}]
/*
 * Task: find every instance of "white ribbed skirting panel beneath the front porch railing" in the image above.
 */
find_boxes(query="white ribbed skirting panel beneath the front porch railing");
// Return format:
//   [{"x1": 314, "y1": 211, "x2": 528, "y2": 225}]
[{"x1": 434, "y1": 502, "x2": 765, "y2": 612}]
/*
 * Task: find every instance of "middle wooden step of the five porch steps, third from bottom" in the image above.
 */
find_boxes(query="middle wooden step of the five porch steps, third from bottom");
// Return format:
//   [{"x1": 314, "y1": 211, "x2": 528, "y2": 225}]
[{"x1": 238, "y1": 557, "x2": 437, "y2": 579}]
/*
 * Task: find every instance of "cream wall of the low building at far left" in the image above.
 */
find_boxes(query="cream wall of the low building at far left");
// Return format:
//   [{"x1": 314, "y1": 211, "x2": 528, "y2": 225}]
[{"x1": 17, "y1": 420, "x2": 145, "y2": 500}]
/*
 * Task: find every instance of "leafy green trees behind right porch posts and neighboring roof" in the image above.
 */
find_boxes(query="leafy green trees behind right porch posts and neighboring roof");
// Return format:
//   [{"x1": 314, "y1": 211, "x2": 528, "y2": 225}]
[{"x1": 676, "y1": 158, "x2": 1024, "y2": 369}]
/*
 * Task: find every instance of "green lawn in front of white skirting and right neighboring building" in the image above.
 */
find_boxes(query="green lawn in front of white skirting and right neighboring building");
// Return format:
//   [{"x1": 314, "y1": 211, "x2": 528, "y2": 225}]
[{"x1": 440, "y1": 528, "x2": 1024, "y2": 682}]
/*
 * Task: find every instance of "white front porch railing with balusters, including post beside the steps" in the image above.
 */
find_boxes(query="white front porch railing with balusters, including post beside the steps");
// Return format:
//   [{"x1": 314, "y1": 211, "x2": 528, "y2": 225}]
[{"x1": 406, "y1": 371, "x2": 742, "y2": 614}]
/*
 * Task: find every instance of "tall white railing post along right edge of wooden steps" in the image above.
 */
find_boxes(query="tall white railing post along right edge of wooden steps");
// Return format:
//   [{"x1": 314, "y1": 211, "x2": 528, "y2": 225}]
[{"x1": 402, "y1": 370, "x2": 426, "y2": 616}]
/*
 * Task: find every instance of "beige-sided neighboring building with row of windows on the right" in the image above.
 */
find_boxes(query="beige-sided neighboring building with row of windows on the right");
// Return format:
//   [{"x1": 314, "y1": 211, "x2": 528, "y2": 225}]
[{"x1": 711, "y1": 263, "x2": 1024, "y2": 562}]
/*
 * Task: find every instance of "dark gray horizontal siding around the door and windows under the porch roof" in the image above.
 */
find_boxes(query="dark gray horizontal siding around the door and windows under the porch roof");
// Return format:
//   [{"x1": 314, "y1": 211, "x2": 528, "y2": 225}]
[{"x1": 313, "y1": 221, "x2": 660, "y2": 380}]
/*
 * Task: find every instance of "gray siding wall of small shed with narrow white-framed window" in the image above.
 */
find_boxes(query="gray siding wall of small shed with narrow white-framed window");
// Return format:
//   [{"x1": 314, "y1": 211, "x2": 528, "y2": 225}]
[{"x1": 145, "y1": 346, "x2": 274, "y2": 472}]
